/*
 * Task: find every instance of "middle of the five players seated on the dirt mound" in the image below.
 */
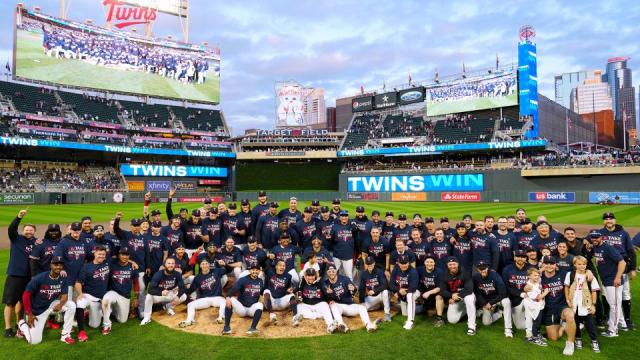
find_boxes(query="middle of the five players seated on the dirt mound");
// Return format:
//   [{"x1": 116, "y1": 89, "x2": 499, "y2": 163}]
[{"x1": 263, "y1": 260, "x2": 300, "y2": 326}]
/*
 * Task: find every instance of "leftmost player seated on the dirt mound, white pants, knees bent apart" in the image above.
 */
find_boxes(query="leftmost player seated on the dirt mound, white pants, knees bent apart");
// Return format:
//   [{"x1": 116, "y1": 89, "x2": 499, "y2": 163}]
[{"x1": 178, "y1": 258, "x2": 225, "y2": 327}]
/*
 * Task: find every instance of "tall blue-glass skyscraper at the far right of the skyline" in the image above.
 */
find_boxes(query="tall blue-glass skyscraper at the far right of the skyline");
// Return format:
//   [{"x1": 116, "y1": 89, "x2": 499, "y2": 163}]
[{"x1": 602, "y1": 56, "x2": 637, "y2": 129}]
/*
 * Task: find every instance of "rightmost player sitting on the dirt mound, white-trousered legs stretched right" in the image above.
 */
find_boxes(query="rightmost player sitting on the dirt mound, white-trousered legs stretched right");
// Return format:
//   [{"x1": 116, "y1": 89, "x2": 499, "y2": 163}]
[{"x1": 323, "y1": 264, "x2": 379, "y2": 333}]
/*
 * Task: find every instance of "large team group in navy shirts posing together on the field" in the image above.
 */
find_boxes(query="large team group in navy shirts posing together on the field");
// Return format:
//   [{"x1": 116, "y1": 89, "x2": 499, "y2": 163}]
[{"x1": 3, "y1": 190, "x2": 638, "y2": 355}]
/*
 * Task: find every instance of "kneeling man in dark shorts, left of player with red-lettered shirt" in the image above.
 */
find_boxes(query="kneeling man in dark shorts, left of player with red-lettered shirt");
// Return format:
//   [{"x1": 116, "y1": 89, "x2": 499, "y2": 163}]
[{"x1": 417, "y1": 254, "x2": 444, "y2": 327}]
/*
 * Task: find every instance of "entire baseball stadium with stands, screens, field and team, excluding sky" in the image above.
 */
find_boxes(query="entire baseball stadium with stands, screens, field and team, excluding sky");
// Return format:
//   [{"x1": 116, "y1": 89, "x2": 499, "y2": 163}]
[{"x1": 0, "y1": 0, "x2": 640, "y2": 359}]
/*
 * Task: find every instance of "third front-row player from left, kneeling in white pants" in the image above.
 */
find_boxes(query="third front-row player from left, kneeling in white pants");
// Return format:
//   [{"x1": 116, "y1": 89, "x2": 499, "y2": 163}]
[{"x1": 102, "y1": 246, "x2": 138, "y2": 335}]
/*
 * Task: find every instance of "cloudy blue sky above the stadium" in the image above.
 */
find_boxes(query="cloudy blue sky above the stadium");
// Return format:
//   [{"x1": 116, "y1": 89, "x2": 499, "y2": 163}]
[{"x1": 0, "y1": 0, "x2": 640, "y2": 134}]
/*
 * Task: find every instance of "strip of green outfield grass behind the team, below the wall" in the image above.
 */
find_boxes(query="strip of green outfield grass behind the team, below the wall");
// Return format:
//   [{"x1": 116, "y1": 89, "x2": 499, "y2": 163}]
[{"x1": 0, "y1": 200, "x2": 640, "y2": 226}]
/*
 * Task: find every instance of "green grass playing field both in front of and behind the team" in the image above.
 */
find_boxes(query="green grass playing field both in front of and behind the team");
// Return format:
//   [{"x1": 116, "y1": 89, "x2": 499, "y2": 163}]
[{"x1": 0, "y1": 202, "x2": 640, "y2": 360}]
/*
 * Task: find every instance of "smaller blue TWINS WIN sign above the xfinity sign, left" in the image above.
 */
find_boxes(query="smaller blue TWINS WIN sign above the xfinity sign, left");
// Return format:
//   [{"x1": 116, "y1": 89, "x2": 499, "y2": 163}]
[{"x1": 120, "y1": 164, "x2": 227, "y2": 177}]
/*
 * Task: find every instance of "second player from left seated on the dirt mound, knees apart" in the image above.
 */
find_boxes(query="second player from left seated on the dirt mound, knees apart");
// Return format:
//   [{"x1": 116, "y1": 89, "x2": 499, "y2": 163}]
[{"x1": 222, "y1": 264, "x2": 264, "y2": 336}]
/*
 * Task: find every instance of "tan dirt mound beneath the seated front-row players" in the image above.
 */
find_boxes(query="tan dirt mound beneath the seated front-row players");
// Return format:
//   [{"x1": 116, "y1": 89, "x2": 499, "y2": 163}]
[{"x1": 152, "y1": 305, "x2": 394, "y2": 339}]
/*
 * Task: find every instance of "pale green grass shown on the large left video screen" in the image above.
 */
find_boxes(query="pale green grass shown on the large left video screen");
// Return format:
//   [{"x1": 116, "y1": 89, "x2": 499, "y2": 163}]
[{"x1": 16, "y1": 30, "x2": 220, "y2": 103}]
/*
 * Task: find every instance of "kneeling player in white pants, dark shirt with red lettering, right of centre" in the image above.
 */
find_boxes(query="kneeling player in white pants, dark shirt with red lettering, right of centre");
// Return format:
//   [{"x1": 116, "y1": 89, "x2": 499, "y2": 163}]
[{"x1": 440, "y1": 256, "x2": 476, "y2": 336}]
